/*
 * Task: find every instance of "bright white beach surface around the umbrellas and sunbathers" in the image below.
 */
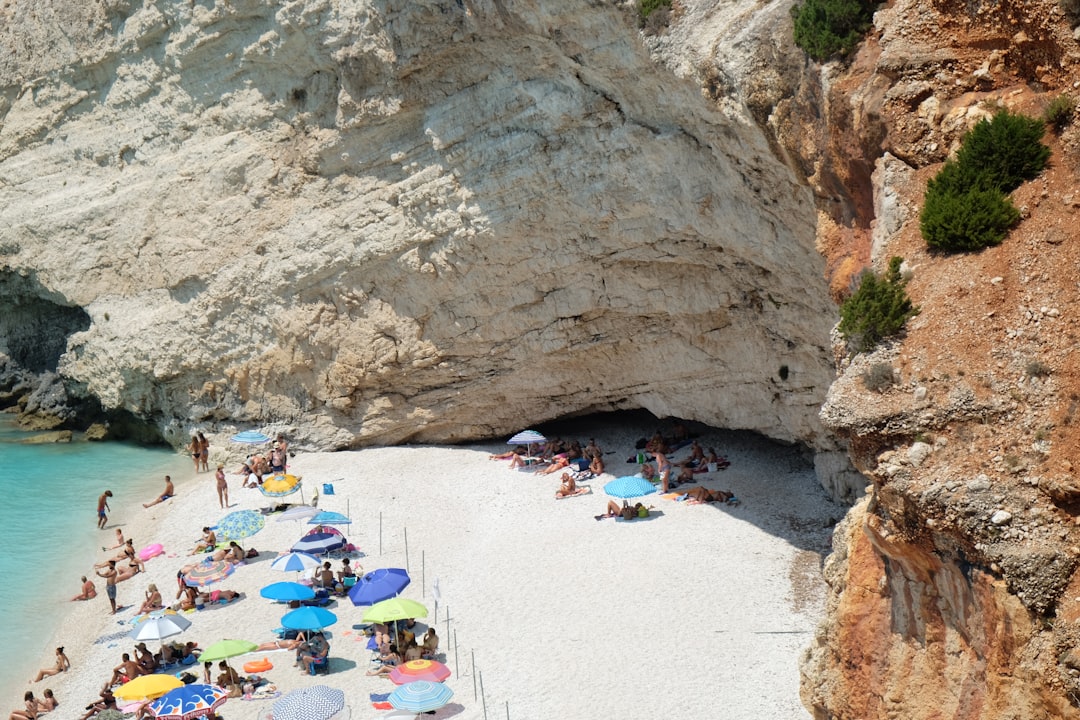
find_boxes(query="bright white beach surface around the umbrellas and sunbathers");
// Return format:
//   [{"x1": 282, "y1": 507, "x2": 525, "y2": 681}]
[{"x1": 21, "y1": 421, "x2": 843, "y2": 720}]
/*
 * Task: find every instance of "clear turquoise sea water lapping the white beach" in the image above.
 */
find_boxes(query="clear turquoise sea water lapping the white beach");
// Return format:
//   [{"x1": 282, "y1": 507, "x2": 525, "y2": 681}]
[{"x1": 0, "y1": 416, "x2": 190, "y2": 707}]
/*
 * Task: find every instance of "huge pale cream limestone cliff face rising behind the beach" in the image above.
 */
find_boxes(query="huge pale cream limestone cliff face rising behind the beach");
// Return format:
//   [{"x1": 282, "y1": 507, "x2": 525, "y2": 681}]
[{"x1": 0, "y1": 0, "x2": 858, "y2": 495}]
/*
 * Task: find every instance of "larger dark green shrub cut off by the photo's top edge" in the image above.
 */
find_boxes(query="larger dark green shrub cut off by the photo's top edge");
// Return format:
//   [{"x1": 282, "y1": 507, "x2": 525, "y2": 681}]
[{"x1": 792, "y1": 0, "x2": 877, "y2": 62}]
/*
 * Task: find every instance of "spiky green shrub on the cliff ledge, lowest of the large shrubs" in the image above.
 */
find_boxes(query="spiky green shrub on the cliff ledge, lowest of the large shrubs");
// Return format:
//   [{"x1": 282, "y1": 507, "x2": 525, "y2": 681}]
[{"x1": 839, "y1": 257, "x2": 919, "y2": 352}]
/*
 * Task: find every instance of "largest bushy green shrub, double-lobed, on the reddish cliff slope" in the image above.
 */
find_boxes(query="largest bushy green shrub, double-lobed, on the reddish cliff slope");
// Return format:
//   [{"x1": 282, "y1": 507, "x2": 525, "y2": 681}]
[{"x1": 919, "y1": 110, "x2": 1050, "y2": 253}]
